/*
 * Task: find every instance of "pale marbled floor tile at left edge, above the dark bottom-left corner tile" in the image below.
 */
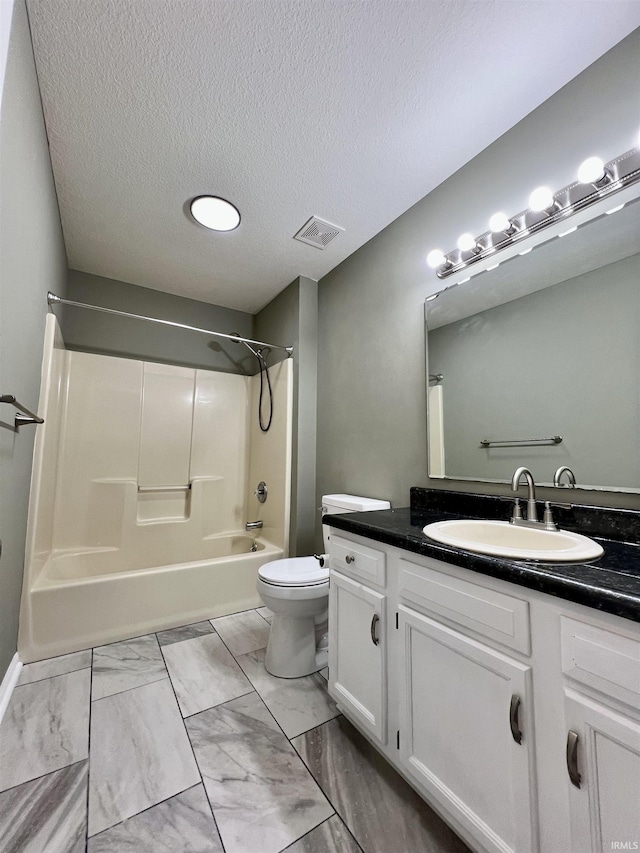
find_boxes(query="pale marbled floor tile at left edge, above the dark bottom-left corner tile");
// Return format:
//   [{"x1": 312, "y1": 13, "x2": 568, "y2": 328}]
[{"x1": 0, "y1": 669, "x2": 91, "y2": 791}]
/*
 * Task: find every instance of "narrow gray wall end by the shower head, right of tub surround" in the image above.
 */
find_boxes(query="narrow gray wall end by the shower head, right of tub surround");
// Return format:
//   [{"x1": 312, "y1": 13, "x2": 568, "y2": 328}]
[{"x1": 256, "y1": 276, "x2": 318, "y2": 556}]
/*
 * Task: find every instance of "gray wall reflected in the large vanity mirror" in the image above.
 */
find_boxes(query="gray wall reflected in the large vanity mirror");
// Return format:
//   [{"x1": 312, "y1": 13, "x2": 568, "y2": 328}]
[{"x1": 429, "y1": 253, "x2": 640, "y2": 489}]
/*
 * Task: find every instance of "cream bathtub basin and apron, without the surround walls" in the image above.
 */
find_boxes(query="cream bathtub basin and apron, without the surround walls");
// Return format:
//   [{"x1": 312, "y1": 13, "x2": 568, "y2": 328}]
[{"x1": 20, "y1": 531, "x2": 284, "y2": 663}]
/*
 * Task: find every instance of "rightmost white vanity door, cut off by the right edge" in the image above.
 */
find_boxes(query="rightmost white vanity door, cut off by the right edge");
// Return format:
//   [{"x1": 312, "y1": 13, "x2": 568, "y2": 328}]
[{"x1": 565, "y1": 690, "x2": 640, "y2": 853}]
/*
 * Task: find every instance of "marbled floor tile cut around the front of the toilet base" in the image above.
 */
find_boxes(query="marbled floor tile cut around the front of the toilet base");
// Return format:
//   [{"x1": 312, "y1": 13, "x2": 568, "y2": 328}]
[{"x1": 238, "y1": 649, "x2": 340, "y2": 738}]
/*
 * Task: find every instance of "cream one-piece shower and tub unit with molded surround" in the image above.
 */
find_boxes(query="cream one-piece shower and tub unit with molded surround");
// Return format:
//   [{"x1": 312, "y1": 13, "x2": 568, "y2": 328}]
[{"x1": 18, "y1": 314, "x2": 292, "y2": 663}]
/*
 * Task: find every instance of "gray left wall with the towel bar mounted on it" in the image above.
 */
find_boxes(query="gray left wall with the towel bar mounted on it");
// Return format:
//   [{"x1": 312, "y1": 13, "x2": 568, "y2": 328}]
[{"x1": 0, "y1": 0, "x2": 67, "y2": 680}]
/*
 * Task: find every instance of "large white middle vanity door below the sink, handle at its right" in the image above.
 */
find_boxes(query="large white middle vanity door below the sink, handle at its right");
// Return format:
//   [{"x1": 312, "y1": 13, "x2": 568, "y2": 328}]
[{"x1": 399, "y1": 606, "x2": 537, "y2": 853}]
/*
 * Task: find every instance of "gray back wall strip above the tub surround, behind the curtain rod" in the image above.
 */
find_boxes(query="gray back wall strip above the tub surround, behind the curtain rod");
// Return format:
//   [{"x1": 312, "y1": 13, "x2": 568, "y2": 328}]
[{"x1": 62, "y1": 270, "x2": 257, "y2": 374}]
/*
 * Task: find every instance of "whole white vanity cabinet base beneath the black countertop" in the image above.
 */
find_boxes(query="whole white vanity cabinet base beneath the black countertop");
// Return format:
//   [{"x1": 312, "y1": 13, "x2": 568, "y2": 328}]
[{"x1": 329, "y1": 531, "x2": 640, "y2": 853}]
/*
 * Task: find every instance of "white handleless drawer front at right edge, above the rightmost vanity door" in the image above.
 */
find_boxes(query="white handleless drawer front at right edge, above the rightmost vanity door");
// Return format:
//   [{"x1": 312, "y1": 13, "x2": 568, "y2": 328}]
[{"x1": 561, "y1": 616, "x2": 640, "y2": 708}]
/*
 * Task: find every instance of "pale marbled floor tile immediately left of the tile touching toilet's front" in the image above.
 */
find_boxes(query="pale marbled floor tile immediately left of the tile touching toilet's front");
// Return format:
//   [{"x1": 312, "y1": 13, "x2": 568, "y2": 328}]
[{"x1": 162, "y1": 628, "x2": 254, "y2": 717}]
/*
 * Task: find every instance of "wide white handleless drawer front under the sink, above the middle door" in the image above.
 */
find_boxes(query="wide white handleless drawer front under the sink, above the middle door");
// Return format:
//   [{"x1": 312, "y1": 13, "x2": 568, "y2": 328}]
[{"x1": 400, "y1": 559, "x2": 531, "y2": 655}]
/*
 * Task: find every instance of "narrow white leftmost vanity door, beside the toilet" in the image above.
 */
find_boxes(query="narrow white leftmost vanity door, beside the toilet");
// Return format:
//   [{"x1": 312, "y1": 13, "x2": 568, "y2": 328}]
[{"x1": 329, "y1": 571, "x2": 387, "y2": 743}]
